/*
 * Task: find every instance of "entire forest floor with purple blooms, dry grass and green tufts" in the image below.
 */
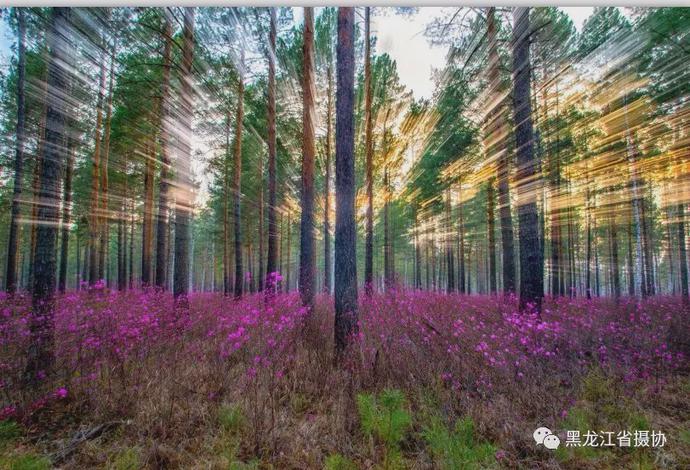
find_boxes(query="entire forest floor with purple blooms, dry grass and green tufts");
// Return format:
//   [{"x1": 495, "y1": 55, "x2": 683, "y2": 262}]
[{"x1": 0, "y1": 290, "x2": 690, "y2": 470}]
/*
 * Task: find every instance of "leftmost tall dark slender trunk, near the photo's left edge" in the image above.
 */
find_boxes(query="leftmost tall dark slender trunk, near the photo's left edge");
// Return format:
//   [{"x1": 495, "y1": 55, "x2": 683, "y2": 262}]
[{"x1": 5, "y1": 8, "x2": 26, "y2": 294}]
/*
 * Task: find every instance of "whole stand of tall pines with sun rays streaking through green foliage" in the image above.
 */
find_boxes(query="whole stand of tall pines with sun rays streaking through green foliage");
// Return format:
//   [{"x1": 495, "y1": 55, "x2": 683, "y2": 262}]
[{"x1": 0, "y1": 7, "x2": 690, "y2": 370}]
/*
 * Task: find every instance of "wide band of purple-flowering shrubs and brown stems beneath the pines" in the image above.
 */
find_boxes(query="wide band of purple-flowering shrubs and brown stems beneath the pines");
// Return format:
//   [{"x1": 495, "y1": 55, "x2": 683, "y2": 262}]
[{"x1": 0, "y1": 288, "x2": 689, "y2": 466}]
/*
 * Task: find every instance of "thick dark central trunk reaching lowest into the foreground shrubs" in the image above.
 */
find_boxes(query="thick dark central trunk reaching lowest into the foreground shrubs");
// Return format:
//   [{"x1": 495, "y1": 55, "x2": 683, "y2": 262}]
[{"x1": 334, "y1": 7, "x2": 358, "y2": 352}]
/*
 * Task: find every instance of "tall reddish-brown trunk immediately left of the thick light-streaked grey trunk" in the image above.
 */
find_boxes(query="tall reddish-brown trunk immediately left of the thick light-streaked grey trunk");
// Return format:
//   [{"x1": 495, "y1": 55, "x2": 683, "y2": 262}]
[{"x1": 155, "y1": 14, "x2": 173, "y2": 289}]
